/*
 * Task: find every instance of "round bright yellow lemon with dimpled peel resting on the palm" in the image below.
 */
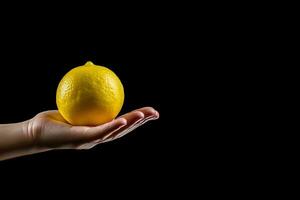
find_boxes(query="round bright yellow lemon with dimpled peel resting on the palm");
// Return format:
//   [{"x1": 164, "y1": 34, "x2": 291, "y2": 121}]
[{"x1": 56, "y1": 61, "x2": 124, "y2": 126}]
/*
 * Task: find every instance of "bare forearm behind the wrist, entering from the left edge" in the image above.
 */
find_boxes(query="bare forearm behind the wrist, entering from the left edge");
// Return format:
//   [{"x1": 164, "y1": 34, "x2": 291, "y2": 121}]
[{"x1": 0, "y1": 121, "x2": 32, "y2": 160}]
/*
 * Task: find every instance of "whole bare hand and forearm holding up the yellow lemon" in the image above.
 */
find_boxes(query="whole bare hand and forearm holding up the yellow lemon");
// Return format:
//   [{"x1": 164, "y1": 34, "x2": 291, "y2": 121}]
[{"x1": 0, "y1": 107, "x2": 159, "y2": 160}]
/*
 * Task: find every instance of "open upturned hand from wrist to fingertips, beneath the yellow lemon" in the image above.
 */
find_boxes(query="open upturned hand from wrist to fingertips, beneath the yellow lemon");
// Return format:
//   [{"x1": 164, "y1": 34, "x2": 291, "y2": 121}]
[{"x1": 27, "y1": 107, "x2": 159, "y2": 149}]
